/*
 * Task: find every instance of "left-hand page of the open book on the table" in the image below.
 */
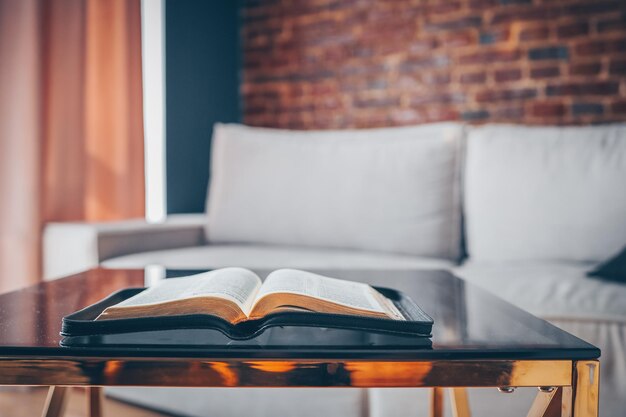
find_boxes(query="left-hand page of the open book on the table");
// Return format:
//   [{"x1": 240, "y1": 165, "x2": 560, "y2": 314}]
[{"x1": 115, "y1": 268, "x2": 261, "y2": 313}]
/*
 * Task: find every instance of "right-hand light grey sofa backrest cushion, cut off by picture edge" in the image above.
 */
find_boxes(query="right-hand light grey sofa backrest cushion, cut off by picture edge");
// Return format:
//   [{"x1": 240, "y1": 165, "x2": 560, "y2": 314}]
[{"x1": 464, "y1": 124, "x2": 626, "y2": 261}]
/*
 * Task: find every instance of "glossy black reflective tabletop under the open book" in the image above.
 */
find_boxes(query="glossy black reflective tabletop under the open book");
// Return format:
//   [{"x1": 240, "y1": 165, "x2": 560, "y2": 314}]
[{"x1": 0, "y1": 269, "x2": 600, "y2": 360}]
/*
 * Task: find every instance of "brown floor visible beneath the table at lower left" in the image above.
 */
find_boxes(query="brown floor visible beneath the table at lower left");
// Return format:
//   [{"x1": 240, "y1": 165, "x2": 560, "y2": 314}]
[{"x1": 0, "y1": 387, "x2": 168, "y2": 417}]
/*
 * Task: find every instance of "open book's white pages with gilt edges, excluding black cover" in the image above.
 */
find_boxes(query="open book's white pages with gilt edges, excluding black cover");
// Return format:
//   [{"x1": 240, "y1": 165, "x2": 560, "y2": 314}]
[{"x1": 97, "y1": 268, "x2": 406, "y2": 324}]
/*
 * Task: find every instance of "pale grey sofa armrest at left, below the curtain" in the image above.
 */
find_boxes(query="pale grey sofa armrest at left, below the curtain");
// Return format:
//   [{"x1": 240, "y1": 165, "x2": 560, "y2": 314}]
[{"x1": 43, "y1": 214, "x2": 206, "y2": 279}]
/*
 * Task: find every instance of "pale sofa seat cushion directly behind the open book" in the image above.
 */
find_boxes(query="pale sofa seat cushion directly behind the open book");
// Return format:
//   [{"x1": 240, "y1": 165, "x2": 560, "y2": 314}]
[{"x1": 103, "y1": 244, "x2": 454, "y2": 269}]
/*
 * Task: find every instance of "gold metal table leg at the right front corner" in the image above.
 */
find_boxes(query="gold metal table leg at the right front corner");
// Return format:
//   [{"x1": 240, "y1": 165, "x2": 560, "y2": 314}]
[{"x1": 571, "y1": 361, "x2": 600, "y2": 417}]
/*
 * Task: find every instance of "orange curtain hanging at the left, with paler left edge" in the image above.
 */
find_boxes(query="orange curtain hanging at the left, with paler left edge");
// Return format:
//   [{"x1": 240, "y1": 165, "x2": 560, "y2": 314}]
[{"x1": 0, "y1": 0, "x2": 144, "y2": 291}]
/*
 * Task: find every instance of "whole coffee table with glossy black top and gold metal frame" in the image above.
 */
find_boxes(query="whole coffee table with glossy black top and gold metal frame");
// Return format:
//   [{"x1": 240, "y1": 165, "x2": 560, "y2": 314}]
[{"x1": 0, "y1": 269, "x2": 600, "y2": 417}]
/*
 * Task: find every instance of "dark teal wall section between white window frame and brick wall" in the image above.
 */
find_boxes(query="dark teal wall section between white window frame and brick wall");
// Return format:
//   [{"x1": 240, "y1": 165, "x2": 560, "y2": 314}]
[{"x1": 165, "y1": 0, "x2": 241, "y2": 213}]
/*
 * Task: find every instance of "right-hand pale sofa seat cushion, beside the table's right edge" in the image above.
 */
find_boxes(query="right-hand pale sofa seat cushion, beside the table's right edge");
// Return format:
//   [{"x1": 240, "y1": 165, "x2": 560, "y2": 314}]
[{"x1": 453, "y1": 261, "x2": 626, "y2": 323}]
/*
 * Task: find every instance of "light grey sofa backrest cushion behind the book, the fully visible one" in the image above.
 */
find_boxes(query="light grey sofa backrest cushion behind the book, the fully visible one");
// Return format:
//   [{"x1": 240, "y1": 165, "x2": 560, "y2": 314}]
[{"x1": 206, "y1": 123, "x2": 464, "y2": 260}]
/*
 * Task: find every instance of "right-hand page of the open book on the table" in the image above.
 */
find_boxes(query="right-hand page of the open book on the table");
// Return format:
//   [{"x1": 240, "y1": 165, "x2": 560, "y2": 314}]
[{"x1": 257, "y1": 269, "x2": 387, "y2": 313}]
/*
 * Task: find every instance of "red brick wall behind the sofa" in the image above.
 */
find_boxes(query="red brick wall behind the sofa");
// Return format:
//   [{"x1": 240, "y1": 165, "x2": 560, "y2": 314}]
[{"x1": 241, "y1": 0, "x2": 626, "y2": 129}]
